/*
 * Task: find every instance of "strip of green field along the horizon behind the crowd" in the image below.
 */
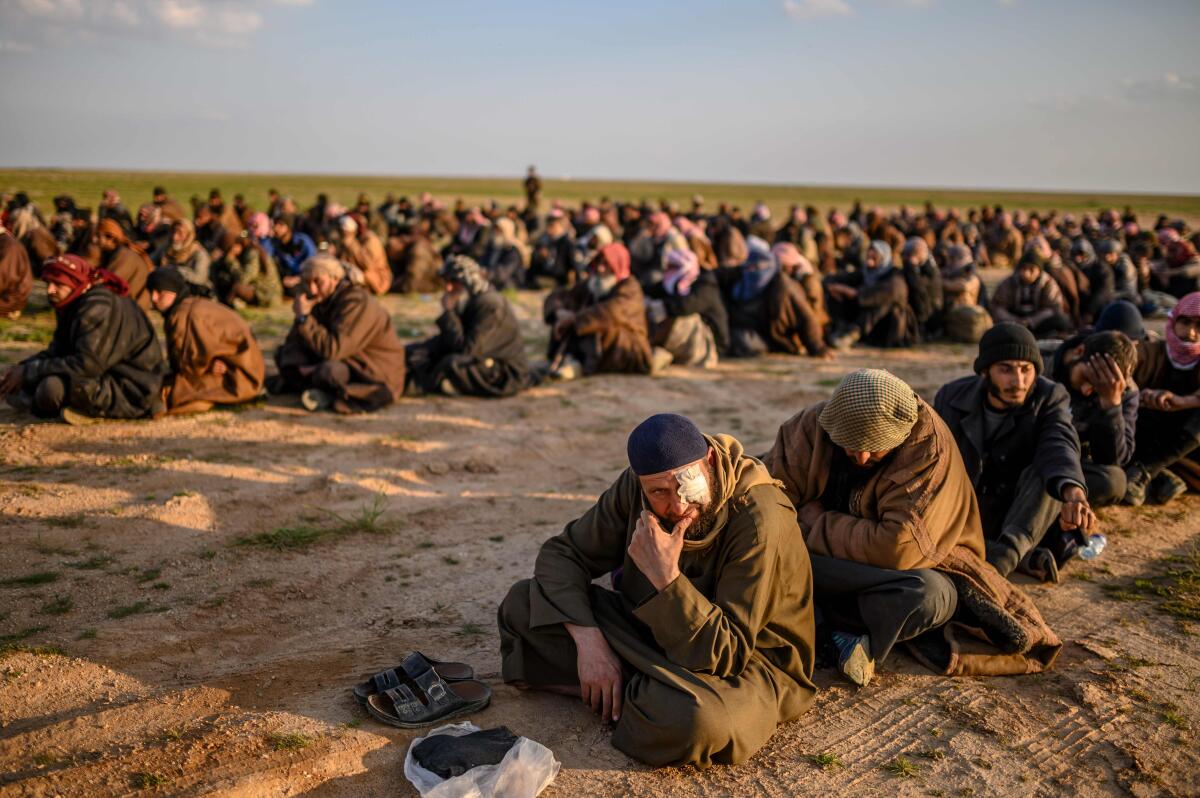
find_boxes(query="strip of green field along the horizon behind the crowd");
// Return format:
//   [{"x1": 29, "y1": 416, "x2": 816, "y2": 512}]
[{"x1": 0, "y1": 169, "x2": 1200, "y2": 223}]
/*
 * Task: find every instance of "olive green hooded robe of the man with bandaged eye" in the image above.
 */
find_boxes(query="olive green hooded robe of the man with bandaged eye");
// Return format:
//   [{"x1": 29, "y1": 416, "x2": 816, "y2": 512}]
[{"x1": 499, "y1": 436, "x2": 816, "y2": 767}]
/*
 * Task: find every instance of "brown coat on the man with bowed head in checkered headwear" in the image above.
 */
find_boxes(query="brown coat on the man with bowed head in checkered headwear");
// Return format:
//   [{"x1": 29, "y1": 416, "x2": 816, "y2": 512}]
[{"x1": 763, "y1": 400, "x2": 1062, "y2": 676}]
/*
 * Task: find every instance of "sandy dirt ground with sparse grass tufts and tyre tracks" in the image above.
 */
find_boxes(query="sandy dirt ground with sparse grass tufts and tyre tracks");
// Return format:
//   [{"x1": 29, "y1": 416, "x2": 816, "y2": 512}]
[{"x1": 0, "y1": 282, "x2": 1200, "y2": 798}]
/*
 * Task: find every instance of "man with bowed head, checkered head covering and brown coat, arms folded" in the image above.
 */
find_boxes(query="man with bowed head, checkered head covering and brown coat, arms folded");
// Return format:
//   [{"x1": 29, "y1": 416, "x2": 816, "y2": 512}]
[{"x1": 763, "y1": 370, "x2": 1060, "y2": 685}]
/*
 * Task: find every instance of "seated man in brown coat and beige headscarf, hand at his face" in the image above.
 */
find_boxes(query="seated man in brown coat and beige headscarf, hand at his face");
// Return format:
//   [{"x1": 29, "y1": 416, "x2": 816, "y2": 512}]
[{"x1": 269, "y1": 254, "x2": 404, "y2": 413}]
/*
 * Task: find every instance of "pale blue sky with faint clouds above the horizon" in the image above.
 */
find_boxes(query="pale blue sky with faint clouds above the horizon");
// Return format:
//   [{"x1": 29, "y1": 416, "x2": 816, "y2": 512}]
[{"x1": 0, "y1": 0, "x2": 1200, "y2": 193}]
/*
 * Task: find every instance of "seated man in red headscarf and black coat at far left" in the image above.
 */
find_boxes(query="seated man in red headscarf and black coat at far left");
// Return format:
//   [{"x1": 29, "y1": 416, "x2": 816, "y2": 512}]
[{"x1": 0, "y1": 254, "x2": 167, "y2": 424}]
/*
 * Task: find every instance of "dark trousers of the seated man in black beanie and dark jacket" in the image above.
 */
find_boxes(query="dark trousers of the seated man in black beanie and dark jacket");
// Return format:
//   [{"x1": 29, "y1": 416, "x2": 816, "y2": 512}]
[{"x1": 979, "y1": 466, "x2": 1062, "y2": 576}]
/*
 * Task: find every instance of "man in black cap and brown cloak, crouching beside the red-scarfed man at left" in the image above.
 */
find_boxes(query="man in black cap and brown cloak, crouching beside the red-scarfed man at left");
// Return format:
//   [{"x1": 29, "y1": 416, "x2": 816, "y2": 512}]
[{"x1": 146, "y1": 269, "x2": 266, "y2": 414}]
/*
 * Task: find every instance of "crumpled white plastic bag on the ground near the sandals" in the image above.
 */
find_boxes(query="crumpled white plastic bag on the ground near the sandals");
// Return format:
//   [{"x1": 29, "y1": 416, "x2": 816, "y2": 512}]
[{"x1": 404, "y1": 722, "x2": 563, "y2": 798}]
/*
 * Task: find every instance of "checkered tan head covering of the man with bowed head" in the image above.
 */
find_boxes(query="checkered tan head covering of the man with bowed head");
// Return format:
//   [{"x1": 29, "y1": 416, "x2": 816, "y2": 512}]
[{"x1": 820, "y1": 368, "x2": 917, "y2": 451}]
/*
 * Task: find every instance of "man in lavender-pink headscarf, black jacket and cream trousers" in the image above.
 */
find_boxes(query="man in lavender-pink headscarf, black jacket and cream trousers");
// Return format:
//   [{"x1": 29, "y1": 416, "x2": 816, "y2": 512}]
[{"x1": 647, "y1": 250, "x2": 730, "y2": 368}]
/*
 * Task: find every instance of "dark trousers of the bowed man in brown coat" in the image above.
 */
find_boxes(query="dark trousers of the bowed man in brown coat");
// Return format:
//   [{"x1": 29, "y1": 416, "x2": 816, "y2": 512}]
[{"x1": 809, "y1": 554, "x2": 959, "y2": 661}]
